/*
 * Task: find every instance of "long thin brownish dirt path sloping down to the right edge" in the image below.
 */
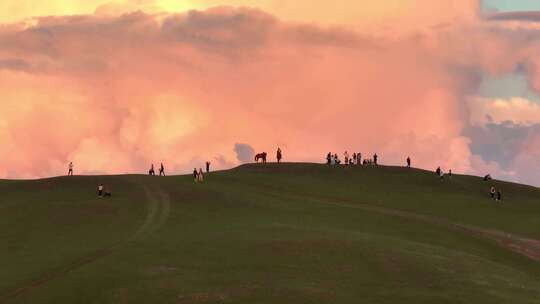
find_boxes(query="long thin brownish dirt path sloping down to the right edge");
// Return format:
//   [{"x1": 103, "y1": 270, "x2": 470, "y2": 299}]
[{"x1": 264, "y1": 192, "x2": 540, "y2": 262}]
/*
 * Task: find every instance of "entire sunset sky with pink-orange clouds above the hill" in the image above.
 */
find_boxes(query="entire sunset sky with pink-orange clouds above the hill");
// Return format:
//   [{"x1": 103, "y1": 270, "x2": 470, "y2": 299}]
[{"x1": 0, "y1": 0, "x2": 540, "y2": 186}]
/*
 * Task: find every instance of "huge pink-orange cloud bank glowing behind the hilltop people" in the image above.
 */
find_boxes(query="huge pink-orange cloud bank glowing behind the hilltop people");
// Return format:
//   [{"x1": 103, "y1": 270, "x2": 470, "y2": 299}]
[{"x1": 0, "y1": 5, "x2": 538, "y2": 184}]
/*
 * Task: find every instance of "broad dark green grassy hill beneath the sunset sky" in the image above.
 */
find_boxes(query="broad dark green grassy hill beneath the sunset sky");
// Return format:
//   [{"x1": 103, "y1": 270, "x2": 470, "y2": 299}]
[{"x1": 0, "y1": 164, "x2": 540, "y2": 304}]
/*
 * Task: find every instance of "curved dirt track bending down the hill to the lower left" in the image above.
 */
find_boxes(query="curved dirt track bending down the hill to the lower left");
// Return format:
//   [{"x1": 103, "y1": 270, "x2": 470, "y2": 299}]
[{"x1": 0, "y1": 185, "x2": 171, "y2": 303}]
